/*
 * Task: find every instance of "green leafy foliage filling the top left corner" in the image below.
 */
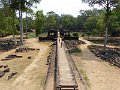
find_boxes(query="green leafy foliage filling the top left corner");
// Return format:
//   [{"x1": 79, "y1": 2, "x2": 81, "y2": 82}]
[{"x1": 0, "y1": 0, "x2": 41, "y2": 37}]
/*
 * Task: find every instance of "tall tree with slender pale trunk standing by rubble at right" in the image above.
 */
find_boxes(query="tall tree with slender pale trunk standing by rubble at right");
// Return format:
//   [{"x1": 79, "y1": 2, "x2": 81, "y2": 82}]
[{"x1": 82, "y1": 0, "x2": 119, "y2": 48}]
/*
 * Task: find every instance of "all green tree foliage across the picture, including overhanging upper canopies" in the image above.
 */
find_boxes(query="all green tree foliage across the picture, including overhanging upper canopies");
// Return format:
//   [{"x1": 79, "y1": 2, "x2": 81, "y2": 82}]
[{"x1": 0, "y1": 0, "x2": 120, "y2": 36}]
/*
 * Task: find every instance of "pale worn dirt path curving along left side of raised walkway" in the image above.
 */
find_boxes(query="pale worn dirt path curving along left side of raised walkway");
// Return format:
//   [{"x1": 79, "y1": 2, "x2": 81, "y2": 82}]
[{"x1": 13, "y1": 39, "x2": 51, "y2": 90}]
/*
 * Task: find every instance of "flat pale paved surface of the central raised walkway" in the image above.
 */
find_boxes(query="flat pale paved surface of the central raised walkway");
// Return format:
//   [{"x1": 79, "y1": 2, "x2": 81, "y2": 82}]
[{"x1": 57, "y1": 37, "x2": 76, "y2": 85}]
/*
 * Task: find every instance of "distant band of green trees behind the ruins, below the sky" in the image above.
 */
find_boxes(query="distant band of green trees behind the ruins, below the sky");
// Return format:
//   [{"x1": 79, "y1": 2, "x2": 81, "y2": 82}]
[{"x1": 0, "y1": 0, "x2": 120, "y2": 36}]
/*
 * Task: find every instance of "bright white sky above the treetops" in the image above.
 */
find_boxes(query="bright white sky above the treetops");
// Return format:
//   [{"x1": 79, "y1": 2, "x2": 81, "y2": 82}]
[{"x1": 34, "y1": 0, "x2": 100, "y2": 17}]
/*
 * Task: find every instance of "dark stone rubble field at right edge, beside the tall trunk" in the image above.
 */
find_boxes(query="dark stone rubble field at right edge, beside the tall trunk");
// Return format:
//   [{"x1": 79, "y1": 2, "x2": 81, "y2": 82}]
[{"x1": 88, "y1": 45, "x2": 120, "y2": 67}]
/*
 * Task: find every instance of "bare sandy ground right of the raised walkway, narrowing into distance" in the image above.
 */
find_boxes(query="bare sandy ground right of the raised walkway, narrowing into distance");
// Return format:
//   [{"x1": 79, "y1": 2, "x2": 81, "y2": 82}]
[{"x1": 73, "y1": 39, "x2": 120, "y2": 90}]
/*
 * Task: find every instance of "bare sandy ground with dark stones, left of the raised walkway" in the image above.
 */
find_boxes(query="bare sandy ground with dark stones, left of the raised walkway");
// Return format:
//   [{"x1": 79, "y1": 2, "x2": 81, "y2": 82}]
[{"x1": 0, "y1": 38, "x2": 52, "y2": 90}]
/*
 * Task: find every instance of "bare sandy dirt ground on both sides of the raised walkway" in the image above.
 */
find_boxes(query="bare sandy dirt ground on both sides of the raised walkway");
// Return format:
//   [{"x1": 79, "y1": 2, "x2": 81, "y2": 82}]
[{"x1": 0, "y1": 35, "x2": 120, "y2": 90}]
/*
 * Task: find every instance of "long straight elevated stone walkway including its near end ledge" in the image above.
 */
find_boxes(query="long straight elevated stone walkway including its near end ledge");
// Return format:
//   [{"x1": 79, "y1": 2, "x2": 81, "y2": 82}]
[{"x1": 57, "y1": 32, "x2": 77, "y2": 90}]
